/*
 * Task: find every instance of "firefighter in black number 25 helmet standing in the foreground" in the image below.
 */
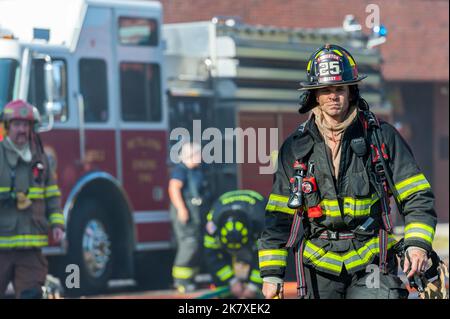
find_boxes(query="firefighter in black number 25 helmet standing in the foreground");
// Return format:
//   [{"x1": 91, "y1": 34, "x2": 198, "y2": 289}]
[{"x1": 259, "y1": 45, "x2": 436, "y2": 299}]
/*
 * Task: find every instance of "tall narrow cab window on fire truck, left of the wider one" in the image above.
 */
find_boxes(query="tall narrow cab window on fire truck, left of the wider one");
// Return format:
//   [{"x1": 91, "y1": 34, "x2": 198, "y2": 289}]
[{"x1": 78, "y1": 59, "x2": 108, "y2": 122}]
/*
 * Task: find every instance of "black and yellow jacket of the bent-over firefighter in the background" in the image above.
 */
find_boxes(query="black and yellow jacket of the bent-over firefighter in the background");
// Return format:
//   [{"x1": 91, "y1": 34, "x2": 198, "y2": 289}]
[{"x1": 204, "y1": 190, "x2": 267, "y2": 286}]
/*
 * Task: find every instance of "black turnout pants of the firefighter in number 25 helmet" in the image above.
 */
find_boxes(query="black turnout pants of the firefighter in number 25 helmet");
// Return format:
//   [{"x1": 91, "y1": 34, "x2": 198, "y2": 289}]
[{"x1": 305, "y1": 258, "x2": 408, "y2": 299}]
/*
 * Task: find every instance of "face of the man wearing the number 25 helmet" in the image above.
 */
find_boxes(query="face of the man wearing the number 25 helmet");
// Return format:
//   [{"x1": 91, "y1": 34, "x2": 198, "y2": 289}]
[{"x1": 316, "y1": 85, "x2": 349, "y2": 121}]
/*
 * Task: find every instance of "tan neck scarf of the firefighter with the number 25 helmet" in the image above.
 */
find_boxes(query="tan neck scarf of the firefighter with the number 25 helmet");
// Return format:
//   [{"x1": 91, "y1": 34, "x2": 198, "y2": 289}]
[{"x1": 312, "y1": 105, "x2": 358, "y2": 178}]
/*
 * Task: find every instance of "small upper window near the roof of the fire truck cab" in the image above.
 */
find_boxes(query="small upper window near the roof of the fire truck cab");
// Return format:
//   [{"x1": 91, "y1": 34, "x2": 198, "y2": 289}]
[{"x1": 119, "y1": 17, "x2": 158, "y2": 46}]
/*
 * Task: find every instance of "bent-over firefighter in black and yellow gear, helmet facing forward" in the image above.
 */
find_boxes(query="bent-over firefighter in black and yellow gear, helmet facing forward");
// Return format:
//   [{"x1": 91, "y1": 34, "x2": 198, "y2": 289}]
[{"x1": 203, "y1": 190, "x2": 266, "y2": 298}]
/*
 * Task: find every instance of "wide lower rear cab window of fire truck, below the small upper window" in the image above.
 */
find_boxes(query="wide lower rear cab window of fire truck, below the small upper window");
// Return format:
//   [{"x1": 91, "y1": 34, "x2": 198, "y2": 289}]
[{"x1": 120, "y1": 62, "x2": 161, "y2": 122}]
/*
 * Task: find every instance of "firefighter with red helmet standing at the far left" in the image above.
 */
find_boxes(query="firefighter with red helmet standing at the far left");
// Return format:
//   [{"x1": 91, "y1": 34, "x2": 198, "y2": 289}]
[{"x1": 0, "y1": 100, "x2": 64, "y2": 298}]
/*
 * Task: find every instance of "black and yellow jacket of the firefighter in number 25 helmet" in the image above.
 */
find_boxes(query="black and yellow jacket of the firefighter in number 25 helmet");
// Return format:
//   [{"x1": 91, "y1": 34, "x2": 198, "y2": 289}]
[{"x1": 259, "y1": 112, "x2": 436, "y2": 278}]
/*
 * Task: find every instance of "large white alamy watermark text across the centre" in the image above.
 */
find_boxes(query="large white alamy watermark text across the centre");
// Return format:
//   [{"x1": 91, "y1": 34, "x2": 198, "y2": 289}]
[{"x1": 169, "y1": 120, "x2": 278, "y2": 175}]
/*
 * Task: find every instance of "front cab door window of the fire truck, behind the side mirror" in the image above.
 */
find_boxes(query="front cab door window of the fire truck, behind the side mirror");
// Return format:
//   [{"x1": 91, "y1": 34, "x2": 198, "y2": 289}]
[{"x1": 28, "y1": 58, "x2": 69, "y2": 122}]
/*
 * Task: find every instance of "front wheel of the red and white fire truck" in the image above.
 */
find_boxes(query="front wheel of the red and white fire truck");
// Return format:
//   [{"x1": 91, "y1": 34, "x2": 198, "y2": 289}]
[{"x1": 69, "y1": 200, "x2": 113, "y2": 294}]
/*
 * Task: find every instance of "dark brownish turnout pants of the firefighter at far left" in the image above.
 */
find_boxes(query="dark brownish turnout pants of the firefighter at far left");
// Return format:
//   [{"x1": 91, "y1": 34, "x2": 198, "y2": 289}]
[{"x1": 0, "y1": 249, "x2": 48, "y2": 299}]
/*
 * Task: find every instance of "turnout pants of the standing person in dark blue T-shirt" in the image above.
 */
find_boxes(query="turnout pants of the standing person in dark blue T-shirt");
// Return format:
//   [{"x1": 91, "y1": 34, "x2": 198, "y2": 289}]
[{"x1": 170, "y1": 203, "x2": 202, "y2": 285}]
